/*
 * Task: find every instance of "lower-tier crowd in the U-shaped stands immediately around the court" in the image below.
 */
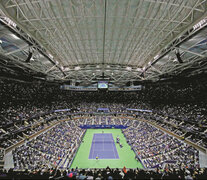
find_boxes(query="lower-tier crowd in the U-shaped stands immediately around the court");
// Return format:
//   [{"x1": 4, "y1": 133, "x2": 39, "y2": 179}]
[{"x1": 10, "y1": 116, "x2": 199, "y2": 172}]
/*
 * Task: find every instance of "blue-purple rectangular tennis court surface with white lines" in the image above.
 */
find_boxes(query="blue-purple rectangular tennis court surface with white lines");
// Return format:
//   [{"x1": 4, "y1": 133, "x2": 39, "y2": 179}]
[{"x1": 89, "y1": 133, "x2": 119, "y2": 159}]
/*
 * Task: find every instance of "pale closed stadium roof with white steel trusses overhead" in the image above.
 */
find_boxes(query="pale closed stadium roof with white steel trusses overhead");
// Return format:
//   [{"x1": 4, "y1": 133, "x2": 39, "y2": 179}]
[{"x1": 0, "y1": 0, "x2": 207, "y2": 85}]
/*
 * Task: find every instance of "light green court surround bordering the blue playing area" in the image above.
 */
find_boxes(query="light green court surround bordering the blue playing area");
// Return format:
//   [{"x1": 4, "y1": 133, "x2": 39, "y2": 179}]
[{"x1": 70, "y1": 129, "x2": 143, "y2": 168}]
